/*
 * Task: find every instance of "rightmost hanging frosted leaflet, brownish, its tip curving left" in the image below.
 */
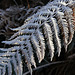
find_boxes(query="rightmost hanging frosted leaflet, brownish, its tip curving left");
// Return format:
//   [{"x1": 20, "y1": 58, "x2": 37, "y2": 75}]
[{"x1": 62, "y1": 7, "x2": 74, "y2": 44}]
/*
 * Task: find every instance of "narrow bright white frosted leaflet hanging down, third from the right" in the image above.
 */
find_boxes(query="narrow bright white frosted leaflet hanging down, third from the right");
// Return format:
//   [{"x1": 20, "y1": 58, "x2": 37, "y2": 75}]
[{"x1": 51, "y1": 17, "x2": 61, "y2": 56}]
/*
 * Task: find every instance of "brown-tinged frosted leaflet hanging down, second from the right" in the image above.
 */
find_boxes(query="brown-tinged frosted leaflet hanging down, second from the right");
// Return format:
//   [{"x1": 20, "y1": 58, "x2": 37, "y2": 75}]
[{"x1": 57, "y1": 12, "x2": 69, "y2": 50}]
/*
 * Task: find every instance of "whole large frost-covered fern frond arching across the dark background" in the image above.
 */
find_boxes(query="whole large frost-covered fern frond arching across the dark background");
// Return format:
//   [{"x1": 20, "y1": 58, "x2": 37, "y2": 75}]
[{"x1": 0, "y1": 0, "x2": 75, "y2": 75}]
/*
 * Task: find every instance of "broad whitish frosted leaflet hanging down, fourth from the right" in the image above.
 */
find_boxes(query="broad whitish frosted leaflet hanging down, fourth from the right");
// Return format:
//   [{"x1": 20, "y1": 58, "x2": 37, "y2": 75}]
[{"x1": 44, "y1": 23, "x2": 54, "y2": 60}]
